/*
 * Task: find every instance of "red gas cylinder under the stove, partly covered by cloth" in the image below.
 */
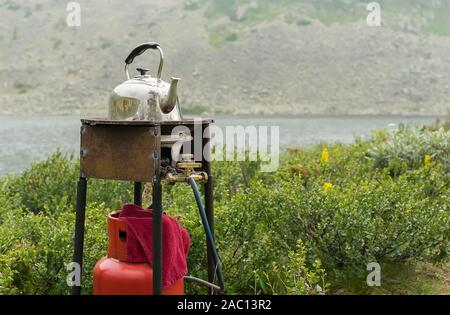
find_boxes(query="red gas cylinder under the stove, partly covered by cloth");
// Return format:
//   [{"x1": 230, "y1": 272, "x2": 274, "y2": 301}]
[{"x1": 93, "y1": 213, "x2": 184, "y2": 295}]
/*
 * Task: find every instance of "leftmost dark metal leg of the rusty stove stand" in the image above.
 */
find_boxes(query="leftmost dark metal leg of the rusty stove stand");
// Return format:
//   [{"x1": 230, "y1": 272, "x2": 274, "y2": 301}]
[{"x1": 72, "y1": 177, "x2": 87, "y2": 295}]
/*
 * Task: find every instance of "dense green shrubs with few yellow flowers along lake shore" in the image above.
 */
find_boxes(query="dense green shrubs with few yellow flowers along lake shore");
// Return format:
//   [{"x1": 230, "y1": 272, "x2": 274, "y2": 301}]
[{"x1": 0, "y1": 129, "x2": 450, "y2": 294}]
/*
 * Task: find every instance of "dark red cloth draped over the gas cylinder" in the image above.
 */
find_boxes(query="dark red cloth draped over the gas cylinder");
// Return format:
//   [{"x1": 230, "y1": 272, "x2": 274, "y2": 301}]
[{"x1": 119, "y1": 204, "x2": 190, "y2": 288}]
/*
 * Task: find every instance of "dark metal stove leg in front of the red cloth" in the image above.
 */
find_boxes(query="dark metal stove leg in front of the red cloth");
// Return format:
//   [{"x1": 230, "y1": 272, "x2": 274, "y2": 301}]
[{"x1": 152, "y1": 178, "x2": 163, "y2": 295}]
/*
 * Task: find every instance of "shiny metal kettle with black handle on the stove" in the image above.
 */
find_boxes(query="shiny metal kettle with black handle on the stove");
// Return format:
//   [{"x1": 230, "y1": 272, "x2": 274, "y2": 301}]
[{"x1": 109, "y1": 42, "x2": 182, "y2": 121}]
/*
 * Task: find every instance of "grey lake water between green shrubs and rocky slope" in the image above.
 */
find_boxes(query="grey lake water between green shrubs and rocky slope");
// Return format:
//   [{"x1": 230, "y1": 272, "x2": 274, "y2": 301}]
[{"x1": 0, "y1": 116, "x2": 435, "y2": 174}]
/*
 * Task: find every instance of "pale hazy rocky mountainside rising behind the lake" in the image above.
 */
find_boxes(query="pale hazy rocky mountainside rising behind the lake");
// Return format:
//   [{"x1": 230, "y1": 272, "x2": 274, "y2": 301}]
[{"x1": 0, "y1": 0, "x2": 450, "y2": 115}]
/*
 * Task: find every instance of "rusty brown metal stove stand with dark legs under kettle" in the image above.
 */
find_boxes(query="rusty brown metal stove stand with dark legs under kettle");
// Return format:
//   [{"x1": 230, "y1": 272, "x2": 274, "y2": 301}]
[{"x1": 72, "y1": 119, "x2": 216, "y2": 295}]
